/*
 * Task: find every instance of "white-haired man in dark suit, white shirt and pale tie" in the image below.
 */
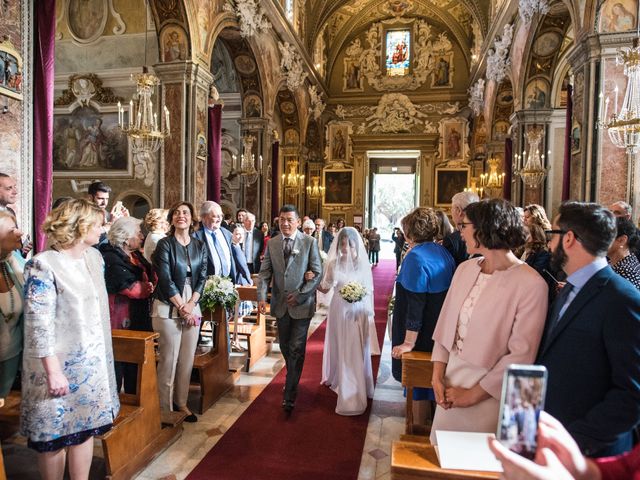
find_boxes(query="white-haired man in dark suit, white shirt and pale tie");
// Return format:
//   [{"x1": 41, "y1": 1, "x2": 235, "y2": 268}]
[{"x1": 193, "y1": 201, "x2": 253, "y2": 285}]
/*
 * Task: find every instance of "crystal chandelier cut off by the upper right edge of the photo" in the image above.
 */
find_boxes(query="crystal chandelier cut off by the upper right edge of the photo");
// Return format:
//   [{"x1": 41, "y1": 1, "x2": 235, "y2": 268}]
[{"x1": 602, "y1": 39, "x2": 640, "y2": 153}]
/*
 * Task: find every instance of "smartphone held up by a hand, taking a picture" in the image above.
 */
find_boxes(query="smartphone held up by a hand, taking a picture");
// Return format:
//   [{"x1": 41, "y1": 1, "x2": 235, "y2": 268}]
[{"x1": 496, "y1": 364, "x2": 547, "y2": 459}]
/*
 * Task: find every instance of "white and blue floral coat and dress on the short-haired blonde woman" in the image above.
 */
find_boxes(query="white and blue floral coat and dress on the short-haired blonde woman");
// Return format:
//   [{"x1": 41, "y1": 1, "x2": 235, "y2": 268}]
[{"x1": 21, "y1": 248, "x2": 120, "y2": 452}]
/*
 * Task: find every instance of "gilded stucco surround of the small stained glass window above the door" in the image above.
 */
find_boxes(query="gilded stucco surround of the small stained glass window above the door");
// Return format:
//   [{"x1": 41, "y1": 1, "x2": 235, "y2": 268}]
[{"x1": 345, "y1": 19, "x2": 453, "y2": 92}]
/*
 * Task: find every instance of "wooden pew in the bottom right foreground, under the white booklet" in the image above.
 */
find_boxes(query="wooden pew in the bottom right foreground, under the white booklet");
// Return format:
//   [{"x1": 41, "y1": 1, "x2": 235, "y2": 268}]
[{"x1": 391, "y1": 441, "x2": 500, "y2": 480}]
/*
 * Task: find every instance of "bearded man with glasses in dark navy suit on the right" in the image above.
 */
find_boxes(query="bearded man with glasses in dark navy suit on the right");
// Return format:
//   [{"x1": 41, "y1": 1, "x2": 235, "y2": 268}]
[{"x1": 537, "y1": 202, "x2": 640, "y2": 457}]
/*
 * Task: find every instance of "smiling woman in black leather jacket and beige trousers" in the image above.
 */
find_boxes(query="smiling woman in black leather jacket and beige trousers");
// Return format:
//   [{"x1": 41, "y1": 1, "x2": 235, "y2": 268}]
[{"x1": 152, "y1": 202, "x2": 207, "y2": 422}]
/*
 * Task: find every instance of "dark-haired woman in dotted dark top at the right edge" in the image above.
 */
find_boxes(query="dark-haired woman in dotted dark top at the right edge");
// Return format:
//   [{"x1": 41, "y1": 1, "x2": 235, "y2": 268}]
[{"x1": 607, "y1": 217, "x2": 640, "y2": 289}]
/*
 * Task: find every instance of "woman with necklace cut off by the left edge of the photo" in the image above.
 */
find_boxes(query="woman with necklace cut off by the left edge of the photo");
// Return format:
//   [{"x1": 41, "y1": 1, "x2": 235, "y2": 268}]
[{"x1": 0, "y1": 211, "x2": 24, "y2": 406}]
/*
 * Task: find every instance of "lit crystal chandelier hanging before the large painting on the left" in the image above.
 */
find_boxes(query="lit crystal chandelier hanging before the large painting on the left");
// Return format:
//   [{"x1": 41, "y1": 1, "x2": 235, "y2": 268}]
[{"x1": 118, "y1": 67, "x2": 171, "y2": 155}]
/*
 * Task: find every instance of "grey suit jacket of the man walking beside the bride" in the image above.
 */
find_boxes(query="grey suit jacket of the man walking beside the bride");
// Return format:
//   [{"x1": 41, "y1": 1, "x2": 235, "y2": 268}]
[{"x1": 257, "y1": 232, "x2": 322, "y2": 318}]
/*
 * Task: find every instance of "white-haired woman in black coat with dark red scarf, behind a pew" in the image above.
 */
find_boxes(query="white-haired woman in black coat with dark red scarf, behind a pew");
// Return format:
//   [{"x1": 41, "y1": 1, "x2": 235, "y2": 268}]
[{"x1": 100, "y1": 217, "x2": 157, "y2": 394}]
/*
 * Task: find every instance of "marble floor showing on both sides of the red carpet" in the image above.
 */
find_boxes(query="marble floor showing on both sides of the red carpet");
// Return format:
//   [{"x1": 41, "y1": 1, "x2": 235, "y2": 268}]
[{"x1": 2, "y1": 314, "x2": 405, "y2": 480}]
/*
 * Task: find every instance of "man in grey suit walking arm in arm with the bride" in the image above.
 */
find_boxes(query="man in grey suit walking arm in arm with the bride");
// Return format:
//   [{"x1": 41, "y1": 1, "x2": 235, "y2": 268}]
[{"x1": 258, "y1": 205, "x2": 322, "y2": 412}]
